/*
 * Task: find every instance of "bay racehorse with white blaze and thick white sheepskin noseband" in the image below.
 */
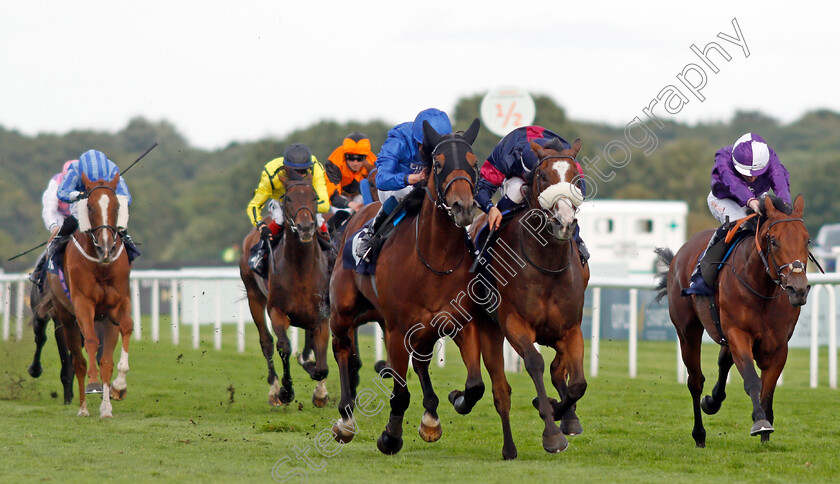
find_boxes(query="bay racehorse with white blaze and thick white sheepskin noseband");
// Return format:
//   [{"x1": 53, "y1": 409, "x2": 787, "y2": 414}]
[{"x1": 473, "y1": 140, "x2": 589, "y2": 453}]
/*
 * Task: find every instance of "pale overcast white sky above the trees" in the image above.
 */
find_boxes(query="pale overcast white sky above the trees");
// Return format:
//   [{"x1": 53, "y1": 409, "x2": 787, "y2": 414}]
[{"x1": 0, "y1": 0, "x2": 840, "y2": 150}]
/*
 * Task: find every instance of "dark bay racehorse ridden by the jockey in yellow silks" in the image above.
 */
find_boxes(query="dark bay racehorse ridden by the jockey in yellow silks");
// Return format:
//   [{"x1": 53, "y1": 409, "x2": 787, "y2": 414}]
[{"x1": 239, "y1": 170, "x2": 330, "y2": 407}]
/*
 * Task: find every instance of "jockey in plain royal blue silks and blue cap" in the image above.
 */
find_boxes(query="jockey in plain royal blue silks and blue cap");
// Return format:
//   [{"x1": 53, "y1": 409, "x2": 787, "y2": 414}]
[{"x1": 355, "y1": 108, "x2": 452, "y2": 262}]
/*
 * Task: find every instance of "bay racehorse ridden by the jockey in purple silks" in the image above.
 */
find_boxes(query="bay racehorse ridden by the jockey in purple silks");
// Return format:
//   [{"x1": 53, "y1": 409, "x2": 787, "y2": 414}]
[{"x1": 657, "y1": 195, "x2": 811, "y2": 447}]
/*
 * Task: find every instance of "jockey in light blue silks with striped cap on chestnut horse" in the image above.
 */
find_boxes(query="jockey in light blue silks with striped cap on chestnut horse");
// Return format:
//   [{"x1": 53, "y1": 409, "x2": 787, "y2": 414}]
[{"x1": 50, "y1": 150, "x2": 140, "y2": 261}]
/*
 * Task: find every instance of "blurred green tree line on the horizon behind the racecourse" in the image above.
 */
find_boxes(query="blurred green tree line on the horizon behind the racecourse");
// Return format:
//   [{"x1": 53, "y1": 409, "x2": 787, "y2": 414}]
[{"x1": 0, "y1": 95, "x2": 840, "y2": 272}]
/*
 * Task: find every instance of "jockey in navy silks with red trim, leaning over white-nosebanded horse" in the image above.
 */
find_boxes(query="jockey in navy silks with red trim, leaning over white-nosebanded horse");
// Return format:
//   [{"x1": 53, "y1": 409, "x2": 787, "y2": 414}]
[{"x1": 475, "y1": 126, "x2": 589, "y2": 264}]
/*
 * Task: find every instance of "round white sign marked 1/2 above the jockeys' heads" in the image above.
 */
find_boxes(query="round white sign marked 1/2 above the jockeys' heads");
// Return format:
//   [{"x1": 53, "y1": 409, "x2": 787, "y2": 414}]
[{"x1": 480, "y1": 86, "x2": 537, "y2": 136}]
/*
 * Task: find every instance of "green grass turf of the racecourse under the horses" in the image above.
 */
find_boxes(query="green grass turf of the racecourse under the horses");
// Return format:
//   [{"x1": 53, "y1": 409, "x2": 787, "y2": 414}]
[{"x1": 0, "y1": 321, "x2": 840, "y2": 483}]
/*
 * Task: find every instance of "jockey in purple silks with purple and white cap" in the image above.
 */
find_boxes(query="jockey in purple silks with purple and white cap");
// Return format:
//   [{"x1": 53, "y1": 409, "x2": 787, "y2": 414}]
[{"x1": 682, "y1": 133, "x2": 791, "y2": 296}]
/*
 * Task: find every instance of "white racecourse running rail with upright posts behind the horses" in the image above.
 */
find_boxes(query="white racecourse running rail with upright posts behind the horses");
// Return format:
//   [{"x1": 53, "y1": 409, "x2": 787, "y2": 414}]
[{"x1": 0, "y1": 268, "x2": 840, "y2": 388}]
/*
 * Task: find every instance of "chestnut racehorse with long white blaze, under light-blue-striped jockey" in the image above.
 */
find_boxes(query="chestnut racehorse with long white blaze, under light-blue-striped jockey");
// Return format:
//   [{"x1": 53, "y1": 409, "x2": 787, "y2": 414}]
[{"x1": 47, "y1": 173, "x2": 134, "y2": 417}]
